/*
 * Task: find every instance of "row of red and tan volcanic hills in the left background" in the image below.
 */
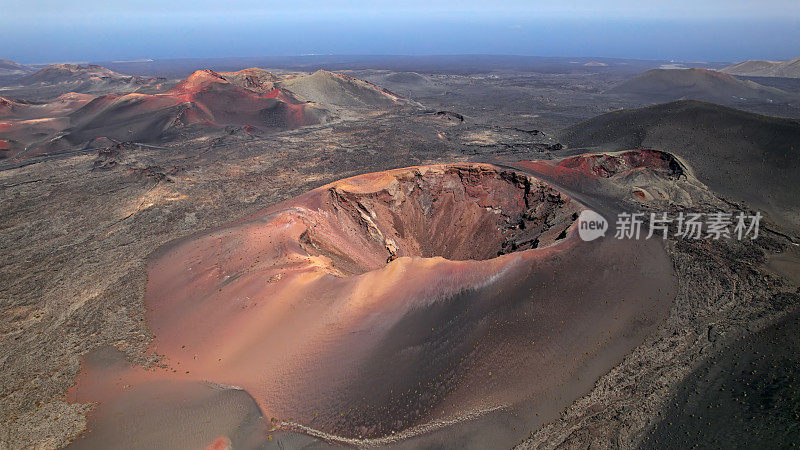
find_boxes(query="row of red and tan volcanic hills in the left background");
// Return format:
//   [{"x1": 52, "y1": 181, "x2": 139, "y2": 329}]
[{"x1": 0, "y1": 64, "x2": 412, "y2": 158}]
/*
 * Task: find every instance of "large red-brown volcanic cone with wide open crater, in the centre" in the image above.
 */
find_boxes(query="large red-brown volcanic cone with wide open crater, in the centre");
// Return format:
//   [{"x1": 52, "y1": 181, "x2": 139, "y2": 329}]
[{"x1": 73, "y1": 164, "x2": 672, "y2": 446}]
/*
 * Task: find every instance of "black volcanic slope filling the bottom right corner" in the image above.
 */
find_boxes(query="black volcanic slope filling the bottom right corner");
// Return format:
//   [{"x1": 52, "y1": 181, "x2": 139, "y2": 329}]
[{"x1": 643, "y1": 312, "x2": 800, "y2": 448}]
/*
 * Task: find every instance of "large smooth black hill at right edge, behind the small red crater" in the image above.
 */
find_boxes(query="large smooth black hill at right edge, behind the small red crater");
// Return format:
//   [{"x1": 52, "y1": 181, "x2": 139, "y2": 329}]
[{"x1": 560, "y1": 101, "x2": 800, "y2": 231}]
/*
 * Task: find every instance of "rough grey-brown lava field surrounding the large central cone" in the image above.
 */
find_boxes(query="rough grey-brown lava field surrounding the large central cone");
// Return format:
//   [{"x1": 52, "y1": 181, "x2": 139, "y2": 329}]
[{"x1": 0, "y1": 60, "x2": 800, "y2": 448}]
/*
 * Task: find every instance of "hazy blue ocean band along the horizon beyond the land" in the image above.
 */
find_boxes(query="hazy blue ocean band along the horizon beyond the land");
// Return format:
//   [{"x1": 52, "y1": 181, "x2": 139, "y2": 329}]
[{"x1": 0, "y1": 13, "x2": 800, "y2": 63}]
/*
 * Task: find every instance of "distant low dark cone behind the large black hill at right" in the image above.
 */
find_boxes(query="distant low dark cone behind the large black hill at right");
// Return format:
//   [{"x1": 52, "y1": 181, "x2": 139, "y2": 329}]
[{"x1": 607, "y1": 69, "x2": 798, "y2": 104}]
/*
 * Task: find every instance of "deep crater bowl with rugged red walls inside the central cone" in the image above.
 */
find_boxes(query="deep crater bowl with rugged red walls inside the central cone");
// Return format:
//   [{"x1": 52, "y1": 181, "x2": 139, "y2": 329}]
[{"x1": 300, "y1": 165, "x2": 580, "y2": 274}]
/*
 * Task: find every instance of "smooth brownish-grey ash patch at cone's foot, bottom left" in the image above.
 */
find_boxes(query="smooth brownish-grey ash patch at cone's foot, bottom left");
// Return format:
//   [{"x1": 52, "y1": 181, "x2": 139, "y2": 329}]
[{"x1": 67, "y1": 347, "x2": 267, "y2": 449}]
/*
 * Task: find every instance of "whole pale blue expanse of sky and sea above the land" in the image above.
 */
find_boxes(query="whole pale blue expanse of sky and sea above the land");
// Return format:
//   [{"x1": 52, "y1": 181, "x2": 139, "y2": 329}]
[{"x1": 0, "y1": 0, "x2": 800, "y2": 63}]
